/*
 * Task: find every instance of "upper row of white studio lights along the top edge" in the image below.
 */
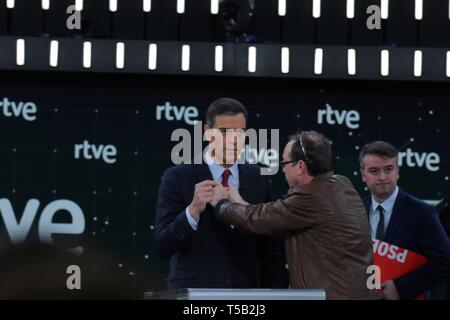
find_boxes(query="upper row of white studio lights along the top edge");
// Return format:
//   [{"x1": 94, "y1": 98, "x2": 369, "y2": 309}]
[{"x1": 6, "y1": 0, "x2": 450, "y2": 20}]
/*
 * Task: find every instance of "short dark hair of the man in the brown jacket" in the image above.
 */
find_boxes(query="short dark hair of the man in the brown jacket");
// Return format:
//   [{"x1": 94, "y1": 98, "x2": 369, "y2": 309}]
[{"x1": 289, "y1": 131, "x2": 333, "y2": 176}]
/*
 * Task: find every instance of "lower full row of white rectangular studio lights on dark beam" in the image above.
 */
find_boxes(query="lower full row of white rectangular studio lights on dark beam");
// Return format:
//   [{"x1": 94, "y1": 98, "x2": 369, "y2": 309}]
[{"x1": 12, "y1": 39, "x2": 450, "y2": 78}]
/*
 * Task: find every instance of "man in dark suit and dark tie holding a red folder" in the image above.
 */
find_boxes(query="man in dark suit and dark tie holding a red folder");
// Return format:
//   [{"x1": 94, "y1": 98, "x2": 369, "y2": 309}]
[{"x1": 359, "y1": 141, "x2": 450, "y2": 299}]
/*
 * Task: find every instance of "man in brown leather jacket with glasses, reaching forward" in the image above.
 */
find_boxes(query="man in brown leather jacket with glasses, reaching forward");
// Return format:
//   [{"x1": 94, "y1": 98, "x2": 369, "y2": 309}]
[{"x1": 211, "y1": 131, "x2": 380, "y2": 299}]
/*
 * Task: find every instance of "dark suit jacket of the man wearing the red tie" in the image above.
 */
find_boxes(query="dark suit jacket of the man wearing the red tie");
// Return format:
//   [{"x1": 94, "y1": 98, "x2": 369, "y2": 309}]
[{"x1": 154, "y1": 164, "x2": 288, "y2": 289}]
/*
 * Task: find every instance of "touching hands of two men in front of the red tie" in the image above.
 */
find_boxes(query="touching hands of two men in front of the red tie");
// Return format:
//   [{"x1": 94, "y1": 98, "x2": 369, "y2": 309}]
[{"x1": 189, "y1": 180, "x2": 247, "y2": 220}]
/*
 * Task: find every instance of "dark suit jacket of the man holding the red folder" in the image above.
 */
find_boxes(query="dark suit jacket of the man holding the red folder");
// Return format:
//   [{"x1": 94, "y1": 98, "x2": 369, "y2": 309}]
[{"x1": 364, "y1": 189, "x2": 450, "y2": 299}]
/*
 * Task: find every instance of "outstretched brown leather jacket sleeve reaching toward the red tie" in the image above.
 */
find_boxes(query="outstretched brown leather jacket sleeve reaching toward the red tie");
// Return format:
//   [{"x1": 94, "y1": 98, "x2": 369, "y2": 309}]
[{"x1": 215, "y1": 190, "x2": 323, "y2": 234}]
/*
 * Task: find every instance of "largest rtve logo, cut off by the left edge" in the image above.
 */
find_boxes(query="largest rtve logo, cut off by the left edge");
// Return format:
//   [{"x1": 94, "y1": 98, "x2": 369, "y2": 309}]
[{"x1": 0, "y1": 198, "x2": 85, "y2": 254}]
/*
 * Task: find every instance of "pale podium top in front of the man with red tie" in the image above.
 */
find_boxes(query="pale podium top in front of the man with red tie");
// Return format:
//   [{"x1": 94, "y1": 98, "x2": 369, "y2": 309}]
[{"x1": 144, "y1": 288, "x2": 326, "y2": 300}]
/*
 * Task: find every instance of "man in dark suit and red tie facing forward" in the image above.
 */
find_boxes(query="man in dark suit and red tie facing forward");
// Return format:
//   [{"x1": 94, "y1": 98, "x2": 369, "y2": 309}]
[{"x1": 154, "y1": 98, "x2": 287, "y2": 289}]
